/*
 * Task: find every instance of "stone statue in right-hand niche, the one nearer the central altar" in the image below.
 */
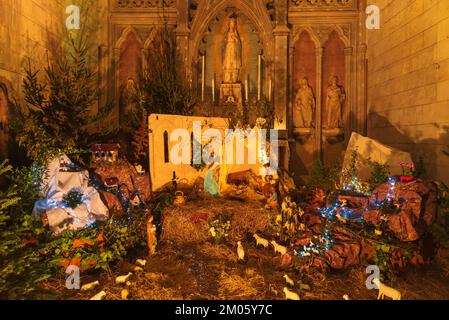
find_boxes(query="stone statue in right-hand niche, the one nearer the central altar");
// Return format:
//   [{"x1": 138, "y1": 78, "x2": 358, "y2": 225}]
[{"x1": 293, "y1": 77, "x2": 315, "y2": 128}]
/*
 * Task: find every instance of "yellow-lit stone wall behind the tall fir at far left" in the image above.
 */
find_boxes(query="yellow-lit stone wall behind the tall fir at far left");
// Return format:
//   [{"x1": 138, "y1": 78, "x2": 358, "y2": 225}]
[{"x1": 0, "y1": 0, "x2": 109, "y2": 159}]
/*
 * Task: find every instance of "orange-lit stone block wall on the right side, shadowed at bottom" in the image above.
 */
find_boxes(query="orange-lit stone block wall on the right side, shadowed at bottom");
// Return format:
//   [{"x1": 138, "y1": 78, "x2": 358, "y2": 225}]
[{"x1": 367, "y1": 0, "x2": 449, "y2": 182}]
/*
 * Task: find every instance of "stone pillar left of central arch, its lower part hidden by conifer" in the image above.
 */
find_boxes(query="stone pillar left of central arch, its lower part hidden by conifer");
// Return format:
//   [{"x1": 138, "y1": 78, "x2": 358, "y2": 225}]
[{"x1": 175, "y1": 0, "x2": 190, "y2": 76}]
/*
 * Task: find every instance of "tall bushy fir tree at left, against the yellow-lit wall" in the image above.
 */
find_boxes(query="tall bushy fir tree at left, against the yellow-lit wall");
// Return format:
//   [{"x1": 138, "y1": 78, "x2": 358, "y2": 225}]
[{"x1": 14, "y1": 1, "x2": 105, "y2": 163}]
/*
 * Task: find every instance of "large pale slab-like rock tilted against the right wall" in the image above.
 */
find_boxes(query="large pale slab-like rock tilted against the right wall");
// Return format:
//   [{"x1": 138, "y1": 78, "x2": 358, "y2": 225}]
[{"x1": 343, "y1": 132, "x2": 413, "y2": 180}]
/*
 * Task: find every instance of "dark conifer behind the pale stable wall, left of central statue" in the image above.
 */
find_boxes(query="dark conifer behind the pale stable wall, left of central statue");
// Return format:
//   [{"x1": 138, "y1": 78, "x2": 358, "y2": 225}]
[{"x1": 139, "y1": 26, "x2": 196, "y2": 115}]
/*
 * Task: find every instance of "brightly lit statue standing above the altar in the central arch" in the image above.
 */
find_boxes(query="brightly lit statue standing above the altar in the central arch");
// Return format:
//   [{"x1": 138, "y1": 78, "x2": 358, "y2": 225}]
[{"x1": 223, "y1": 18, "x2": 242, "y2": 83}]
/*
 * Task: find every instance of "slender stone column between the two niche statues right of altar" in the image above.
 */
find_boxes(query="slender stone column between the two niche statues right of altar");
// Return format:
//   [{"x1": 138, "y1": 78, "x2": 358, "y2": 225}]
[{"x1": 314, "y1": 47, "x2": 323, "y2": 160}]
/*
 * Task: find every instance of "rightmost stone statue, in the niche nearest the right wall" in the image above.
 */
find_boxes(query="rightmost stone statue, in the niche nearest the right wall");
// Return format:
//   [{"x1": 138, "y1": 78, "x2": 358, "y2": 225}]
[{"x1": 326, "y1": 76, "x2": 346, "y2": 128}]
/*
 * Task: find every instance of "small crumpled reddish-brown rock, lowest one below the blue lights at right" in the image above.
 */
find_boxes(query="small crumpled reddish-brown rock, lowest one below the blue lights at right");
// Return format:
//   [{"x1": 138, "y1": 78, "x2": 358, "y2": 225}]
[{"x1": 325, "y1": 241, "x2": 360, "y2": 270}]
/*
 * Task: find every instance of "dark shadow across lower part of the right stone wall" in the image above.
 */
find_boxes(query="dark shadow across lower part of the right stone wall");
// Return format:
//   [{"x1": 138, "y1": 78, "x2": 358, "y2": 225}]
[{"x1": 368, "y1": 113, "x2": 449, "y2": 183}]
